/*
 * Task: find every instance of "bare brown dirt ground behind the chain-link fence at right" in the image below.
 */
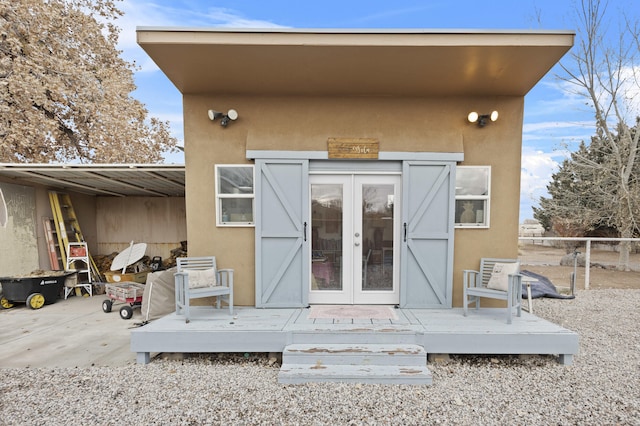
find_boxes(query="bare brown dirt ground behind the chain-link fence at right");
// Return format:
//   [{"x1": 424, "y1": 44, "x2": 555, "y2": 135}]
[{"x1": 518, "y1": 244, "x2": 640, "y2": 290}]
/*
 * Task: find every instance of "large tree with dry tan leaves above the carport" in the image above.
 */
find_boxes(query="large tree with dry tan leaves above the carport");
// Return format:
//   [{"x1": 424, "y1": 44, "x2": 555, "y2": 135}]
[{"x1": 0, "y1": 0, "x2": 176, "y2": 163}]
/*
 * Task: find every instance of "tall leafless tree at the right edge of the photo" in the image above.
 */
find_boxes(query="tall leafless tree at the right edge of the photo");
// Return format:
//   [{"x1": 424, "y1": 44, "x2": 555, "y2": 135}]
[{"x1": 561, "y1": 0, "x2": 640, "y2": 270}]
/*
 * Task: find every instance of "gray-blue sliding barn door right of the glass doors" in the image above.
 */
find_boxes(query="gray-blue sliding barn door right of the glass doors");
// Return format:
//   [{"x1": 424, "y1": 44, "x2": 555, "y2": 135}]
[{"x1": 400, "y1": 161, "x2": 455, "y2": 308}]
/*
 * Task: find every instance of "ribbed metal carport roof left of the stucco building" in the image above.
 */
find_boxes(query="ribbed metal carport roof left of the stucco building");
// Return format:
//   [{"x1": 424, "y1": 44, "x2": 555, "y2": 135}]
[{"x1": 0, "y1": 163, "x2": 185, "y2": 197}]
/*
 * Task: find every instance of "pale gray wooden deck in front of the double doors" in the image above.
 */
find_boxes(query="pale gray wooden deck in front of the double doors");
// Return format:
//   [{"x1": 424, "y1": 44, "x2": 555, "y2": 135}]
[{"x1": 131, "y1": 307, "x2": 578, "y2": 365}]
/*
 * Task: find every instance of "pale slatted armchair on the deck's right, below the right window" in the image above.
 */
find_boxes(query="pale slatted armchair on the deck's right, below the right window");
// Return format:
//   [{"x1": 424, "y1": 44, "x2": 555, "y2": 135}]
[{"x1": 462, "y1": 258, "x2": 522, "y2": 324}]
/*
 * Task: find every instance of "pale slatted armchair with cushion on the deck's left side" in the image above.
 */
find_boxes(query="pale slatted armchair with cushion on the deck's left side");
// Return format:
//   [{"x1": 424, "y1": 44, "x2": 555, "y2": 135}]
[{"x1": 174, "y1": 256, "x2": 233, "y2": 322}]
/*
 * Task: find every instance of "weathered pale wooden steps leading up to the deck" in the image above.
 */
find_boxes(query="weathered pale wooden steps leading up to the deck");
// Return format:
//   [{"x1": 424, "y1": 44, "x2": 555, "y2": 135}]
[{"x1": 278, "y1": 343, "x2": 432, "y2": 385}]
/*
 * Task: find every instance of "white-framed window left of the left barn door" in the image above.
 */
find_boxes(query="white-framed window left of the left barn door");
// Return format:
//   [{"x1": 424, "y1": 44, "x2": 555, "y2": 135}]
[{"x1": 216, "y1": 164, "x2": 255, "y2": 226}]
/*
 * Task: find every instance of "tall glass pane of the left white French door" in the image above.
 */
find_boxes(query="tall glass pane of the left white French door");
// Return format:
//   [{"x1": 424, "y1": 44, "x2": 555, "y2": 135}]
[{"x1": 311, "y1": 184, "x2": 343, "y2": 291}]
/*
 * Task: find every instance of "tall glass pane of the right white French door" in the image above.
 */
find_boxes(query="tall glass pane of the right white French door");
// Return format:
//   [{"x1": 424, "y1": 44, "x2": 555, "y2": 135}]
[{"x1": 362, "y1": 184, "x2": 394, "y2": 291}]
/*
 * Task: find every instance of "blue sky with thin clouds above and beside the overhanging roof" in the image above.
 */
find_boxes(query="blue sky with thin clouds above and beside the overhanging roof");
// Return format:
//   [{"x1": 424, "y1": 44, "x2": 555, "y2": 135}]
[{"x1": 112, "y1": 0, "x2": 637, "y2": 221}]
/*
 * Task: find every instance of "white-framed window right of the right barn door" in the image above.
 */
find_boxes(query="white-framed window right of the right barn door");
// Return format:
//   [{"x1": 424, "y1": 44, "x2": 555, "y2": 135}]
[{"x1": 455, "y1": 166, "x2": 491, "y2": 228}]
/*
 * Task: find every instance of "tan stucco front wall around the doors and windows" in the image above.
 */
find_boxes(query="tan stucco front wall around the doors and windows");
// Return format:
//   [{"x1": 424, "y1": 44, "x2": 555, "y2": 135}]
[{"x1": 184, "y1": 95, "x2": 523, "y2": 306}]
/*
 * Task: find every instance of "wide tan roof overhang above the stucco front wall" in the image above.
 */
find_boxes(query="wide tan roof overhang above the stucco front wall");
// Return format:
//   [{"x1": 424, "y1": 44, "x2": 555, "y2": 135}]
[{"x1": 137, "y1": 27, "x2": 575, "y2": 96}]
